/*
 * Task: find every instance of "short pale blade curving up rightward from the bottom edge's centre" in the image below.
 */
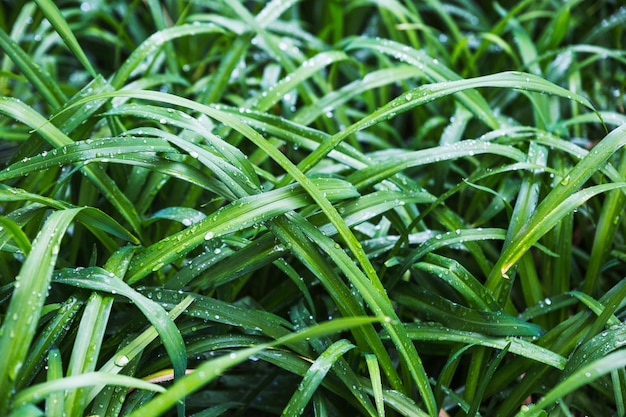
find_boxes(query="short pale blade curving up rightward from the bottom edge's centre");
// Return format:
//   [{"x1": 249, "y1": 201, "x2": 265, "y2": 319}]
[{"x1": 282, "y1": 339, "x2": 355, "y2": 416}]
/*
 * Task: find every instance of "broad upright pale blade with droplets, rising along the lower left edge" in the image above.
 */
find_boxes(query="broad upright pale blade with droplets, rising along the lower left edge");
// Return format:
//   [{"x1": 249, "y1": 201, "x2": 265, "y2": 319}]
[{"x1": 0, "y1": 209, "x2": 87, "y2": 414}]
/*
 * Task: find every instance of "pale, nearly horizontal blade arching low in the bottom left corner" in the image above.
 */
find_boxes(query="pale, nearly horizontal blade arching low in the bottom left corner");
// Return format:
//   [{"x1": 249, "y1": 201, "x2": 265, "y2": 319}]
[{"x1": 15, "y1": 372, "x2": 165, "y2": 406}]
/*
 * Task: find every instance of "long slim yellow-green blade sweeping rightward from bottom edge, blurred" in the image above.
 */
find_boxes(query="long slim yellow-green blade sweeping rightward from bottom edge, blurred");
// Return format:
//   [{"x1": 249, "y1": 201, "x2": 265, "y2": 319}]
[{"x1": 124, "y1": 317, "x2": 380, "y2": 417}]
